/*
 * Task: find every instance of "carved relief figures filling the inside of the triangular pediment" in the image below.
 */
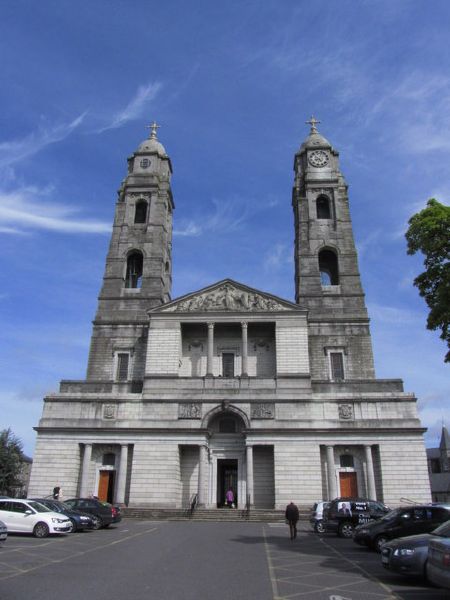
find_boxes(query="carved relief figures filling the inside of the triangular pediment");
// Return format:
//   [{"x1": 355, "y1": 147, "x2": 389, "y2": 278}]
[{"x1": 165, "y1": 283, "x2": 289, "y2": 312}]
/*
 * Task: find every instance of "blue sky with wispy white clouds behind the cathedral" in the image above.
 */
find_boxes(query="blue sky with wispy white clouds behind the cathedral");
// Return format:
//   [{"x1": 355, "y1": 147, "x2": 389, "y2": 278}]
[{"x1": 0, "y1": 0, "x2": 450, "y2": 455}]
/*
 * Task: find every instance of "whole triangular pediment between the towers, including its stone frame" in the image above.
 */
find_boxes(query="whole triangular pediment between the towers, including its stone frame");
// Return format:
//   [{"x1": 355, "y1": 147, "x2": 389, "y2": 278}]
[{"x1": 150, "y1": 279, "x2": 302, "y2": 313}]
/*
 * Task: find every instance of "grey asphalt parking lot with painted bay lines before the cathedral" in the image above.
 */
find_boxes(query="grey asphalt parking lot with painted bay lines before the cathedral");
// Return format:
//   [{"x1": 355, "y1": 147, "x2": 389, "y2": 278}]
[{"x1": 0, "y1": 520, "x2": 448, "y2": 600}]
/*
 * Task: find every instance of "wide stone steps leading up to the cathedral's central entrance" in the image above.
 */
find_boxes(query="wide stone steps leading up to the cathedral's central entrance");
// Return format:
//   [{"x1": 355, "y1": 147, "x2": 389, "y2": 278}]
[{"x1": 122, "y1": 507, "x2": 310, "y2": 523}]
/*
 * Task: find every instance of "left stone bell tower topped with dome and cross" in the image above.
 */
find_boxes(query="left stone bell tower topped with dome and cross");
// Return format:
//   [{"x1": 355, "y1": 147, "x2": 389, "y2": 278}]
[{"x1": 87, "y1": 123, "x2": 174, "y2": 381}]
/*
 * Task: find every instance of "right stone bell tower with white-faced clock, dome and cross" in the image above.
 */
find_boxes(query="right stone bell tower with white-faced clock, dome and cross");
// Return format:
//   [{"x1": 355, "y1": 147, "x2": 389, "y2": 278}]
[{"x1": 292, "y1": 117, "x2": 375, "y2": 381}]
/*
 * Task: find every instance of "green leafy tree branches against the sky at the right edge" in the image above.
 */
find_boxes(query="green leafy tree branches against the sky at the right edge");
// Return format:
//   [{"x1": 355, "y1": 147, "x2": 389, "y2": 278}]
[{"x1": 406, "y1": 198, "x2": 450, "y2": 362}]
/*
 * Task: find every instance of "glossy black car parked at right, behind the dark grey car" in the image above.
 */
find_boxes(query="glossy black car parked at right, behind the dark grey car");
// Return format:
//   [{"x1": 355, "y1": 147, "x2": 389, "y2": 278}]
[{"x1": 353, "y1": 504, "x2": 450, "y2": 552}]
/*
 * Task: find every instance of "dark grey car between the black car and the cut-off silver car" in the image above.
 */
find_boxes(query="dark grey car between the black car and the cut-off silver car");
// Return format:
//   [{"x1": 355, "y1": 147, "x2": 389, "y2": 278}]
[{"x1": 381, "y1": 521, "x2": 450, "y2": 577}]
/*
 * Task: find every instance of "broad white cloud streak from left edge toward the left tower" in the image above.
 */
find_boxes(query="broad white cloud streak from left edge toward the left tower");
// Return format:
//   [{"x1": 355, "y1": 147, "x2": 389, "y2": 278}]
[{"x1": 0, "y1": 188, "x2": 111, "y2": 235}]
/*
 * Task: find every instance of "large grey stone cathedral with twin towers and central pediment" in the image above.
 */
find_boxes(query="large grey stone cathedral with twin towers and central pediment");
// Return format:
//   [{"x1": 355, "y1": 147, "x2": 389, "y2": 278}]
[{"x1": 29, "y1": 118, "x2": 431, "y2": 509}]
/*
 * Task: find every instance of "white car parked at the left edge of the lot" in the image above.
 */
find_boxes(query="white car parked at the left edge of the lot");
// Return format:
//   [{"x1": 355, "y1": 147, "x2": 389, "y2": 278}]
[{"x1": 0, "y1": 498, "x2": 72, "y2": 537}]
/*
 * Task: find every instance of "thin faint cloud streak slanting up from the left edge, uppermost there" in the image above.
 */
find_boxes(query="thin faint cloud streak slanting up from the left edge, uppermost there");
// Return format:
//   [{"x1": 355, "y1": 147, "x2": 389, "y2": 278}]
[{"x1": 0, "y1": 112, "x2": 87, "y2": 168}]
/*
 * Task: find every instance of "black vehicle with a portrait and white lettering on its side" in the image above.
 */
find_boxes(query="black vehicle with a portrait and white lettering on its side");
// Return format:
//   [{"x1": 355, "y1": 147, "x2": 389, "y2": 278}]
[{"x1": 323, "y1": 498, "x2": 390, "y2": 538}]
